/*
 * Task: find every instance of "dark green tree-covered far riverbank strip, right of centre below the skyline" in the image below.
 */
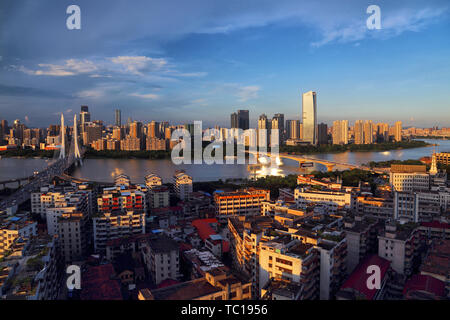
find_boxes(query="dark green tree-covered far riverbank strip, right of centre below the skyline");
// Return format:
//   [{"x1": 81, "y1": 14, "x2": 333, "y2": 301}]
[{"x1": 280, "y1": 140, "x2": 431, "y2": 154}]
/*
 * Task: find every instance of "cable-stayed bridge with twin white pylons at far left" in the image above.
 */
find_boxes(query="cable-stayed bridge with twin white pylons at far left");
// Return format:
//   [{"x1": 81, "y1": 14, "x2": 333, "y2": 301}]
[{"x1": 0, "y1": 114, "x2": 84, "y2": 210}]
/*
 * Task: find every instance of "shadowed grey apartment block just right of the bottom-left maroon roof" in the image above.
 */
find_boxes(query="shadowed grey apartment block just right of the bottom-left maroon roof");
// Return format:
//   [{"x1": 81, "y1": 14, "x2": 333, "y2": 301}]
[{"x1": 142, "y1": 235, "x2": 180, "y2": 284}]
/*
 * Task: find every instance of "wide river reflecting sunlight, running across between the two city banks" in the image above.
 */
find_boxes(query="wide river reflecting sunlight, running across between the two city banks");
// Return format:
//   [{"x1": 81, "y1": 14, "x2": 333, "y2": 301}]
[{"x1": 0, "y1": 139, "x2": 450, "y2": 183}]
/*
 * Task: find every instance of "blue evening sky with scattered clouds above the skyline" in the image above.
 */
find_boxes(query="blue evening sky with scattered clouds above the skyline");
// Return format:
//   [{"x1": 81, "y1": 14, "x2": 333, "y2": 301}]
[{"x1": 0, "y1": 0, "x2": 450, "y2": 127}]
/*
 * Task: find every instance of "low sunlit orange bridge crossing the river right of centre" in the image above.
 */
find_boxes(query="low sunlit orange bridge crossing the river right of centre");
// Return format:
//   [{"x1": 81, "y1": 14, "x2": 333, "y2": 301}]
[{"x1": 247, "y1": 151, "x2": 390, "y2": 174}]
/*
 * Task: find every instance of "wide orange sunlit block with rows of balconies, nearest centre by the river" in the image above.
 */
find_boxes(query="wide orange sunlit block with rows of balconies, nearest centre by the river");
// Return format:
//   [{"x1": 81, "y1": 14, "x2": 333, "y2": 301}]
[{"x1": 214, "y1": 188, "x2": 270, "y2": 219}]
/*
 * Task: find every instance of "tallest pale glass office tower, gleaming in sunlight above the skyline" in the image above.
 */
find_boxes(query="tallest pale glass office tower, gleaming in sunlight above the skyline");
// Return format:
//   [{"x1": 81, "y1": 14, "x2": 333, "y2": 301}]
[{"x1": 302, "y1": 91, "x2": 317, "y2": 145}]
